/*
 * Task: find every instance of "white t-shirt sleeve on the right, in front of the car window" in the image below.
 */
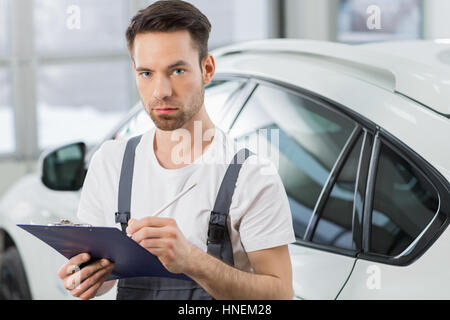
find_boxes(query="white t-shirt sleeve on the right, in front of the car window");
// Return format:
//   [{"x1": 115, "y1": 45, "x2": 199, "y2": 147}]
[{"x1": 230, "y1": 155, "x2": 296, "y2": 252}]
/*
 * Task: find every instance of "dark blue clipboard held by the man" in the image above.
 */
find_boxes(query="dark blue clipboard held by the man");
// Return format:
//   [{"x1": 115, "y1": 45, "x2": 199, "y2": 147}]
[{"x1": 17, "y1": 224, "x2": 192, "y2": 281}]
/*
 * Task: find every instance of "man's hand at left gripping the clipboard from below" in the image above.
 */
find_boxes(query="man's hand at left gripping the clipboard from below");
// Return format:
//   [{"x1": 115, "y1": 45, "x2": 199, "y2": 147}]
[{"x1": 58, "y1": 253, "x2": 114, "y2": 300}]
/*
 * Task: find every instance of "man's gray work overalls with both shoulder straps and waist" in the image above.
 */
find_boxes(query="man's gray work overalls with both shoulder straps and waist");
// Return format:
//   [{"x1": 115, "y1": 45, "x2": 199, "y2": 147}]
[{"x1": 115, "y1": 135, "x2": 253, "y2": 300}]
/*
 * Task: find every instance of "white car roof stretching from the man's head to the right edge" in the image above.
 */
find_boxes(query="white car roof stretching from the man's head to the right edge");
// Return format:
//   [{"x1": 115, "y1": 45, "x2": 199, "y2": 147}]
[{"x1": 212, "y1": 39, "x2": 450, "y2": 117}]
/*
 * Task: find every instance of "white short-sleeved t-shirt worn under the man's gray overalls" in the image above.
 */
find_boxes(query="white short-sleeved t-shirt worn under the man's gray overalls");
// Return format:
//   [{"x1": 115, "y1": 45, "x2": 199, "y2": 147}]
[{"x1": 78, "y1": 126, "x2": 295, "y2": 272}]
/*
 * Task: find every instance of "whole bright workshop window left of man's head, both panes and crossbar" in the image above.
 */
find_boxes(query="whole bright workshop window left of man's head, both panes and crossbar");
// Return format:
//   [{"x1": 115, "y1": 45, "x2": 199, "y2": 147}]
[{"x1": 33, "y1": 0, "x2": 132, "y2": 149}]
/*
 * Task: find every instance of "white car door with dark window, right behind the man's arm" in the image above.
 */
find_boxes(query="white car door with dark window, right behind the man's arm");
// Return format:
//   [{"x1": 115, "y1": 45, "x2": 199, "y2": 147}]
[{"x1": 229, "y1": 82, "x2": 371, "y2": 299}]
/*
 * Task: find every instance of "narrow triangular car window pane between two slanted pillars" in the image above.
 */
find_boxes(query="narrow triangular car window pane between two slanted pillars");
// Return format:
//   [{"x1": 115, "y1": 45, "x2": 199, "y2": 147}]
[{"x1": 312, "y1": 135, "x2": 363, "y2": 249}]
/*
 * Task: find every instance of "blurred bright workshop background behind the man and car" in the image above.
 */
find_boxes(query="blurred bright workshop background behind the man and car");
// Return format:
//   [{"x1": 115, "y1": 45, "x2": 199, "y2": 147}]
[{"x1": 0, "y1": 0, "x2": 450, "y2": 197}]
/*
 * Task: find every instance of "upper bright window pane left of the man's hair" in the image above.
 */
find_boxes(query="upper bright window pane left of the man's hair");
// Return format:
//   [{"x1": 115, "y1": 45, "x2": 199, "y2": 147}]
[{"x1": 34, "y1": 0, "x2": 129, "y2": 56}]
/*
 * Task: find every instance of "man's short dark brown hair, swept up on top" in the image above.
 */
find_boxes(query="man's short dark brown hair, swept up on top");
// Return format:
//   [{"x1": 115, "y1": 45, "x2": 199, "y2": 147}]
[{"x1": 126, "y1": 0, "x2": 211, "y2": 63}]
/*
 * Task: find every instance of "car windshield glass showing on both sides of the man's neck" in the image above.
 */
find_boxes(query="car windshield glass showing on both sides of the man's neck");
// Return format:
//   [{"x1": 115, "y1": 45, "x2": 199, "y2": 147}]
[{"x1": 114, "y1": 80, "x2": 245, "y2": 139}]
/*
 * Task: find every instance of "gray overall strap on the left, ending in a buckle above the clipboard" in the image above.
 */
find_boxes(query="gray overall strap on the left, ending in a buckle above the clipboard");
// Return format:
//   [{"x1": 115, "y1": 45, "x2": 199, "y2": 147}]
[{"x1": 115, "y1": 135, "x2": 142, "y2": 232}]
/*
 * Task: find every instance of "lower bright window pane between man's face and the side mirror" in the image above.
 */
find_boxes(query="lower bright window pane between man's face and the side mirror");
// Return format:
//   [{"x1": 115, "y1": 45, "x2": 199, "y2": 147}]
[{"x1": 37, "y1": 61, "x2": 131, "y2": 148}]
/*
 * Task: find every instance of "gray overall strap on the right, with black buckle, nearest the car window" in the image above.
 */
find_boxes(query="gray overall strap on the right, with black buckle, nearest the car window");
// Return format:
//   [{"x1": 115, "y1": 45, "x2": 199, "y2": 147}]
[{"x1": 207, "y1": 148, "x2": 253, "y2": 266}]
